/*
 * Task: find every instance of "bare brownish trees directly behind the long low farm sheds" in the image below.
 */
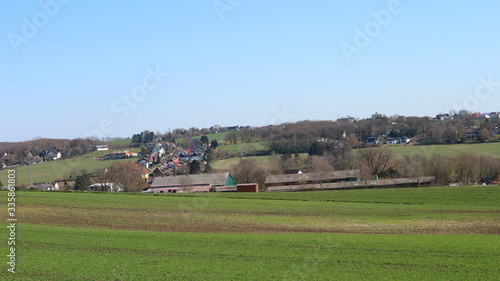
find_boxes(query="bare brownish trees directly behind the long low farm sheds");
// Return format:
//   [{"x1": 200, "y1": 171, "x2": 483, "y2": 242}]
[{"x1": 231, "y1": 146, "x2": 500, "y2": 189}]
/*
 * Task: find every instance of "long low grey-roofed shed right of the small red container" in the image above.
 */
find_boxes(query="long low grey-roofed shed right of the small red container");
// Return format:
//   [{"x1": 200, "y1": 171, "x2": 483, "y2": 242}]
[{"x1": 265, "y1": 170, "x2": 359, "y2": 189}]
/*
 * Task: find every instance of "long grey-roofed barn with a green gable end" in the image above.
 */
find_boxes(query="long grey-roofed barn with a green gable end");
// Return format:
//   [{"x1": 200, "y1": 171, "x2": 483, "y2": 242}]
[{"x1": 148, "y1": 173, "x2": 236, "y2": 193}]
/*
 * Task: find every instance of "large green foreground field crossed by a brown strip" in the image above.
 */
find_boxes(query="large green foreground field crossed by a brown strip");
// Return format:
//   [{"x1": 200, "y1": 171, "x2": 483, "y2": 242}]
[{"x1": 0, "y1": 186, "x2": 500, "y2": 280}]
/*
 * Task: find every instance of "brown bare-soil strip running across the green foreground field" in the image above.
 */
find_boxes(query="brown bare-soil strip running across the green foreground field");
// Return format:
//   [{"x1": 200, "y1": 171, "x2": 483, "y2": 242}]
[{"x1": 19, "y1": 205, "x2": 500, "y2": 235}]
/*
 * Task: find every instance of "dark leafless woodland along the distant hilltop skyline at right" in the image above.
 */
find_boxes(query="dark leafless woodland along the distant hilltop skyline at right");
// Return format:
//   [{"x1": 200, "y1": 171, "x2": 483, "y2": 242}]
[{"x1": 226, "y1": 113, "x2": 500, "y2": 153}]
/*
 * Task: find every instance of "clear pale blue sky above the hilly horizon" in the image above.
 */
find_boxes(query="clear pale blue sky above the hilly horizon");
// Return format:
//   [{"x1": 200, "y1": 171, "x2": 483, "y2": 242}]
[{"x1": 0, "y1": 0, "x2": 500, "y2": 141}]
